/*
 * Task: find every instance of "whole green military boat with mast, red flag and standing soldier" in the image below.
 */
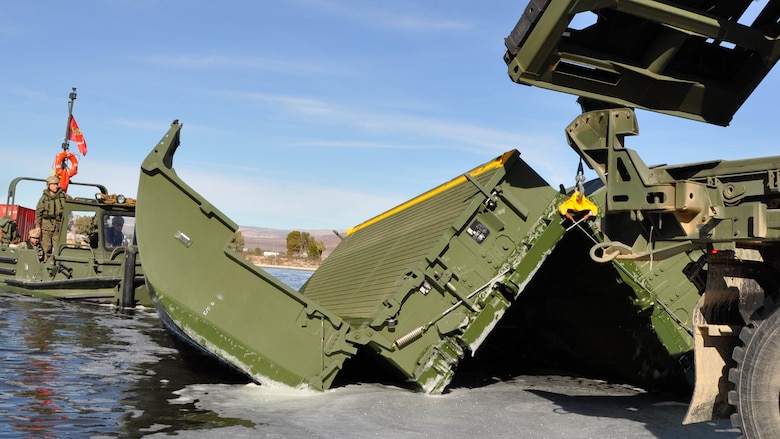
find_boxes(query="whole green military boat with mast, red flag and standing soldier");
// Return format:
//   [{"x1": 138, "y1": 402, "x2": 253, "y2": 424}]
[{"x1": 0, "y1": 87, "x2": 151, "y2": 308}]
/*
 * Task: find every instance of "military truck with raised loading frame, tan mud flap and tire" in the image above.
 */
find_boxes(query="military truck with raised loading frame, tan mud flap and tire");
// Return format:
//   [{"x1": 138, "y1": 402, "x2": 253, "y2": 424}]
[{"x1": 504, "y1": 0, "x2": 780, "y2": 438}]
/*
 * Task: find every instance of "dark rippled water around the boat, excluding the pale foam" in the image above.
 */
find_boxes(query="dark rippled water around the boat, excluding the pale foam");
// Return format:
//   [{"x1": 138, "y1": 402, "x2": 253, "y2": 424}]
[{"x1": 0, "y1": 269, "x2": 311, "y2": 438}]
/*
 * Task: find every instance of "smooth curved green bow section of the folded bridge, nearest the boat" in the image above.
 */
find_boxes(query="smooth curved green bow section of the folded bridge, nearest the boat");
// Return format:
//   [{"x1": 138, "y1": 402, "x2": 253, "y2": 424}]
[{"x1": 136, "y1": 123, "x2": 355, "y2": 389}]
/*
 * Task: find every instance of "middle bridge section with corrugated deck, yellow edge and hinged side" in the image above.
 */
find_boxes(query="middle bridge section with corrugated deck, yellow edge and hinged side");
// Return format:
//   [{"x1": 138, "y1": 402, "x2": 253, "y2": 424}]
[{"x1": 302, "y1": 151, "x2": 565, "y2": 393}]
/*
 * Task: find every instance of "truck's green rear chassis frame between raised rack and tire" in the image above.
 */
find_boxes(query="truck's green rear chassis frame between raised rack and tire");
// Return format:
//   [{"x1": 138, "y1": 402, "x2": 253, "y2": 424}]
[{"x1": 566, "y1": 108, "x2": 780, "y2": 259}]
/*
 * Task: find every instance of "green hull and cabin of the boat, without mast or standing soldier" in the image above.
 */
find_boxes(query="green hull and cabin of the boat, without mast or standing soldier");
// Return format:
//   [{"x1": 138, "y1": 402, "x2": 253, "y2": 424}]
[{"x1": 0, "y1": 177, "x2": 151, "y2": 307}]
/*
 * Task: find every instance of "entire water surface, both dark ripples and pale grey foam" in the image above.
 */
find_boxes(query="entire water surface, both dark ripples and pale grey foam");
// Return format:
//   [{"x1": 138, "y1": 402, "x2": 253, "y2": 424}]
[{"x1": 0, "y1": 269, "x2": 737, "y2": 439}]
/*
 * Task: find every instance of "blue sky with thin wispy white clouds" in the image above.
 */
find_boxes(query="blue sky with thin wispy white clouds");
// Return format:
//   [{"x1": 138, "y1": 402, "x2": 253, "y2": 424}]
[{"x1": 0, "y1": 0, "x2": 780, "y2": 229}]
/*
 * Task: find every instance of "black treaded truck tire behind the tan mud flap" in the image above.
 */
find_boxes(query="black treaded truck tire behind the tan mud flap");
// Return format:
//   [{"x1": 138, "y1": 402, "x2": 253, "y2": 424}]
[{"x1": 728, "y1": 300, "x2": 780, "y2": 439}]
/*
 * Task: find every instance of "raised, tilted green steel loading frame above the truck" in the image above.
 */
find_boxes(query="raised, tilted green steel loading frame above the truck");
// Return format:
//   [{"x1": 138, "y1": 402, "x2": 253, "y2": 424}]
[{"x1": 504, "y1": 0, "x2": 780, "y2": 125}]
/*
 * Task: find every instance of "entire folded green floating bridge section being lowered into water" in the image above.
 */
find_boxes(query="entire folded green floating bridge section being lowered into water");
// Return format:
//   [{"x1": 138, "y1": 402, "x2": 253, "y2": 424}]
[{"x1": 136, "y1": 121, "x2": 698, "y2": 394}]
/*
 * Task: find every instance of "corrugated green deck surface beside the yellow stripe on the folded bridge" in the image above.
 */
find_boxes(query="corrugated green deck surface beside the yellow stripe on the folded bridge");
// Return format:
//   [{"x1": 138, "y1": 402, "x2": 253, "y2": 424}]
[{"x1": 304, "y1": 159, "x2": 505, "y2": 318}]
